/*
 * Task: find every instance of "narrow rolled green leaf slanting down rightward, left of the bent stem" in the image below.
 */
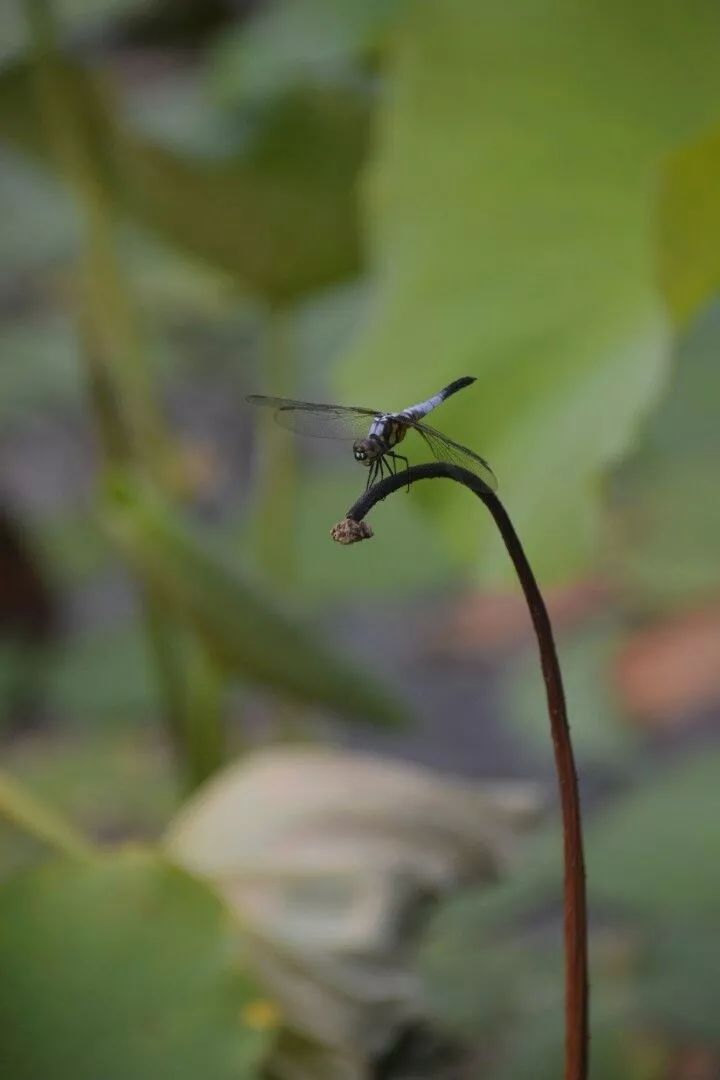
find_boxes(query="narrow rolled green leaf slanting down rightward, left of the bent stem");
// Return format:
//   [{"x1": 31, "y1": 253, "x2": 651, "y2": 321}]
[{"x1": 102, "y1": 485, "x2": 403, "y2": 724}]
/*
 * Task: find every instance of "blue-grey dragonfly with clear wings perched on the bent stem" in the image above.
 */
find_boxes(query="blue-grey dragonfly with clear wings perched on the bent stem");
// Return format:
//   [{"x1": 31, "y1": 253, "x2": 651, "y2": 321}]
[{"x1": 245, "y1": 375, "x2": 498, "y2": 491}]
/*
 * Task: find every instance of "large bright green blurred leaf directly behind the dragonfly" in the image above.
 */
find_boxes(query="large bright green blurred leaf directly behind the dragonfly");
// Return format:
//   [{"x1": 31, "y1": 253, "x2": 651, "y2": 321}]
[{"x1": 337, "y1": 0, "x2": 720, "y2": 579}]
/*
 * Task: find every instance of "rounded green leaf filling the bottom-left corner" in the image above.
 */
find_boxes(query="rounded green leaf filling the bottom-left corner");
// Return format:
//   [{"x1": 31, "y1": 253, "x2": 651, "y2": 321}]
[{"x1": 0, "y1": 851, "x2": 273, "y2": 1080}]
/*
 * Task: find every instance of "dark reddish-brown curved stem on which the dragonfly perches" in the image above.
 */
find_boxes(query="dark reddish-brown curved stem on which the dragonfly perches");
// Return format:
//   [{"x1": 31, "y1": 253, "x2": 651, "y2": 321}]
[{"x1": 347, "y1": 462, "x2": 588, "y2": 1080}]
